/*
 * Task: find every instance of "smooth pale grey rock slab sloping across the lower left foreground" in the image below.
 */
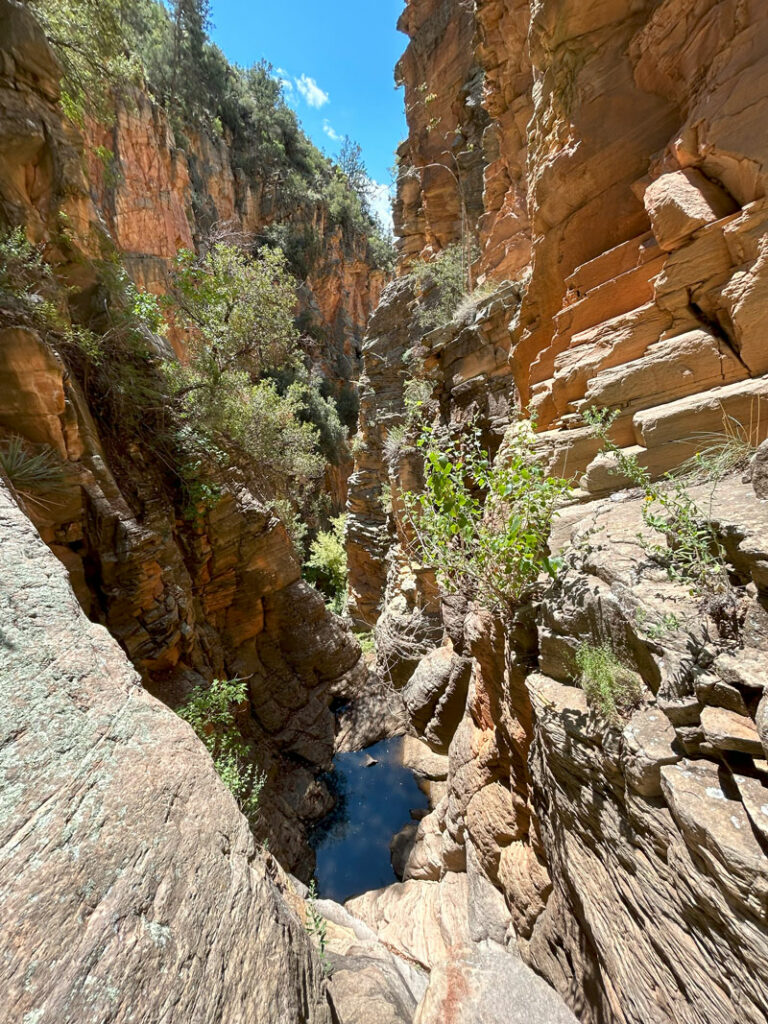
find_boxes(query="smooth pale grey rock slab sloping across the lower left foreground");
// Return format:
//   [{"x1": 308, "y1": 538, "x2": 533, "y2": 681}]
[{"x1": 0, "y1": 481, "x2": 331, "y2": 1024}]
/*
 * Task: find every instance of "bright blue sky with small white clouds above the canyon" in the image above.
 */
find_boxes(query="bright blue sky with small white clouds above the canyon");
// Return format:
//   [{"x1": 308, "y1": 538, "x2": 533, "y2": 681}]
[{"x1": 211, "y1": 0, "x2": 408, "y2": 228}]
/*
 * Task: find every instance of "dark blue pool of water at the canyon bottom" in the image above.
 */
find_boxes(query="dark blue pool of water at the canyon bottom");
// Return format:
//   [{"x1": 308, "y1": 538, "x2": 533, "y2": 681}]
[{"x1": 315, "y1": 738, "x2": 434, "y2": 903}]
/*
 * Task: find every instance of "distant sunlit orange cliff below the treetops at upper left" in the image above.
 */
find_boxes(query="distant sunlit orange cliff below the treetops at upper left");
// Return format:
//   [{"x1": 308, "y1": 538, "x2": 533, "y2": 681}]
[{"x1": 86, "y1": 89, "x2": 384, "y2": 381}]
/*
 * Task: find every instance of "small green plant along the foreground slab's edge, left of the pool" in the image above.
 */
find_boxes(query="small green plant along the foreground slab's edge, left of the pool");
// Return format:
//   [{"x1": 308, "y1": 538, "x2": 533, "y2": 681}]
[{"x1": 177, "y1": 679, "x2": 266, "y2": 825}]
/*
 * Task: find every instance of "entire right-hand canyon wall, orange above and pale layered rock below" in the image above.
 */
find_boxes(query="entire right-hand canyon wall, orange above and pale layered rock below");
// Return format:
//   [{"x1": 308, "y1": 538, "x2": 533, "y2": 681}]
[{"x1": 348, "y1": 0, "x2": 768, "y2": 1024}]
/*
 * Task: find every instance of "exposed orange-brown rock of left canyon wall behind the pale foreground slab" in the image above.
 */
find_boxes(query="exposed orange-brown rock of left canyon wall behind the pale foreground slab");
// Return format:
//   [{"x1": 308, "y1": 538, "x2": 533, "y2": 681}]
[{"x1": 0, "y1": 0, "x2": 378, "y2": 874}]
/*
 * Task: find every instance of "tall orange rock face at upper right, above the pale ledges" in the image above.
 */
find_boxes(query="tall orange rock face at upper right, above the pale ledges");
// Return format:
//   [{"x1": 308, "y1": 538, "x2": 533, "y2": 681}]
[{"x1": 396, "y1": 0, "x2": 768, "y2": 489}]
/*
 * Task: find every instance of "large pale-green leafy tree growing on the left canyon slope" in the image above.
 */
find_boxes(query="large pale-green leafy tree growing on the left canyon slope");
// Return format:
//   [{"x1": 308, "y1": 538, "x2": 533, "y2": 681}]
[{"x1": 165, "y1": 243, "x2": 341, "y2": 520}]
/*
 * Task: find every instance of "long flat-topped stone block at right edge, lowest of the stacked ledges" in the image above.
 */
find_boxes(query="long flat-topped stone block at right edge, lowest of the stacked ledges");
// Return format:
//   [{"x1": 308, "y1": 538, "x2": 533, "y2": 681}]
[{"x1": 633, "y1": 377, "x2": 768, "y2": 447}]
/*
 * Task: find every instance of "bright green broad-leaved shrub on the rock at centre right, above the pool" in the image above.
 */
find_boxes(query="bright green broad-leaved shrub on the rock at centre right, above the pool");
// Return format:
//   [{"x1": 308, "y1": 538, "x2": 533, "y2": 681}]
[{"x1": 403, "y1": 422, "x2": 569, "y2": 611}]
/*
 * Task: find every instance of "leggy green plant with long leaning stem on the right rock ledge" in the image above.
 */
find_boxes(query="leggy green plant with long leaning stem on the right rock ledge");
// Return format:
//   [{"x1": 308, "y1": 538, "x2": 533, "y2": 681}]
[{"x1": 584, "y1": 409, "x2": 728, "y2": 593}]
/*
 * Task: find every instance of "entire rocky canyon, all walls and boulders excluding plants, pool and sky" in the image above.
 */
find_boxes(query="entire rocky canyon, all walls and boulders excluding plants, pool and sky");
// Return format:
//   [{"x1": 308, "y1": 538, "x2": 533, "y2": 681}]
[{"x1": 0, "y1": 0, "x2": 768, "y2": 1024}]
